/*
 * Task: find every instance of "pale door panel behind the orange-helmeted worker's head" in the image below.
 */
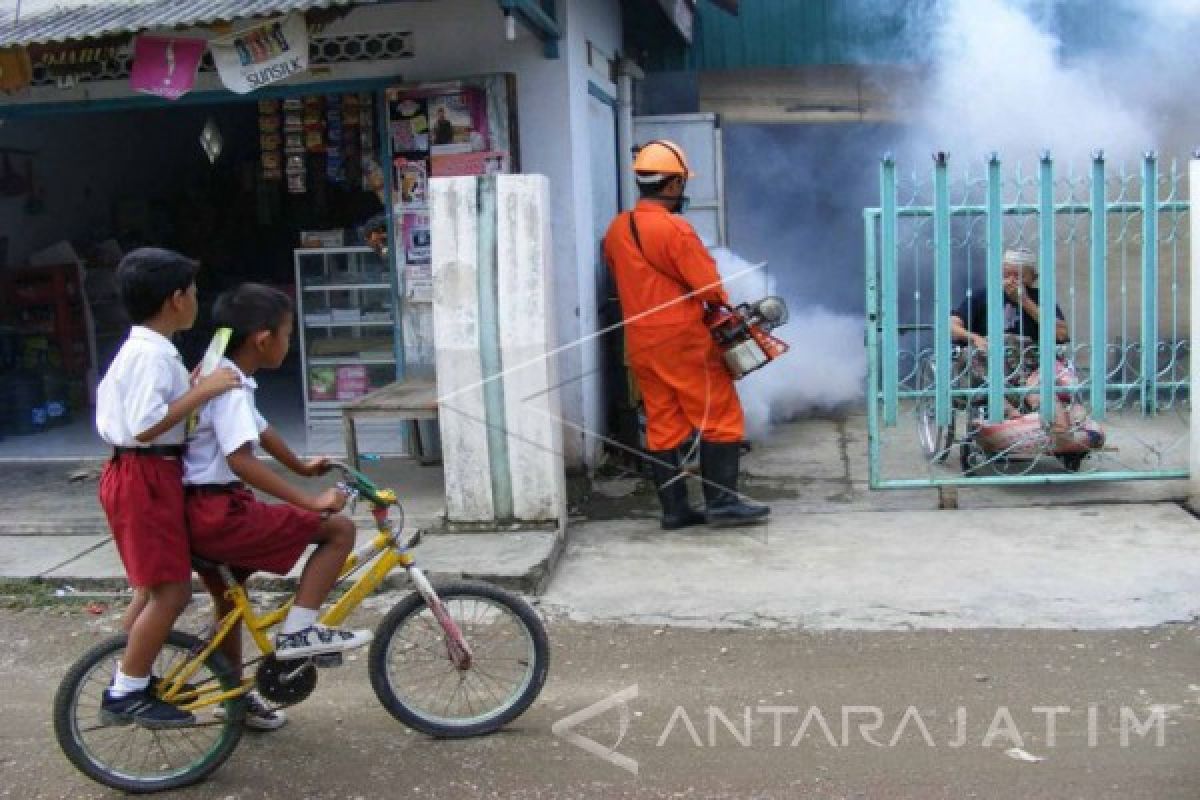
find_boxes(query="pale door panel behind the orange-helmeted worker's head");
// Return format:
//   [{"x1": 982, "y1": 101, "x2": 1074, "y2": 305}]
[{"x1": 634, "y1": 114, "x2": 726, "y2": 247}]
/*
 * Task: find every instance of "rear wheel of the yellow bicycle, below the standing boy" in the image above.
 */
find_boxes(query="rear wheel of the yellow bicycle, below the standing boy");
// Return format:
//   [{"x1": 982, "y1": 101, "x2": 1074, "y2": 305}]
[{"x1": 54, "y1": 631, "x2": 245, "y2": 793}]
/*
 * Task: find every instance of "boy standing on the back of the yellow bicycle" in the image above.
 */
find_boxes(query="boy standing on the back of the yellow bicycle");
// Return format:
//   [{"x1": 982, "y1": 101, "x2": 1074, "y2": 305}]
[{"x1": 96, "y1": 247, "x2": 238, "y2": 728}]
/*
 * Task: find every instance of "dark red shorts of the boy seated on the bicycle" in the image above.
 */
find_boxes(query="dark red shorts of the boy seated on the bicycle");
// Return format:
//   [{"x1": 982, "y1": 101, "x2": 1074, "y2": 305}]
[{"x1": 185, "y1": 488, "x2": 322, "y2": 575}]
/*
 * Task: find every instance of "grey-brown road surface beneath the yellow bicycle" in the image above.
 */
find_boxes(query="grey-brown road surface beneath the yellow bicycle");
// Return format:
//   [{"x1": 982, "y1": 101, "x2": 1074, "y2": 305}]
[{"x1": 0, "y1": 604, "x2": 1200, "y2": 800}]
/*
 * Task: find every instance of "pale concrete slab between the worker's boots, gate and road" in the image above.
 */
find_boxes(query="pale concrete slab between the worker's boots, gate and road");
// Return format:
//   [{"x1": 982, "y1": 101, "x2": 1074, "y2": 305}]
[{"x1": 542, "y1": 504, "x2": 1200, "y2": 630}]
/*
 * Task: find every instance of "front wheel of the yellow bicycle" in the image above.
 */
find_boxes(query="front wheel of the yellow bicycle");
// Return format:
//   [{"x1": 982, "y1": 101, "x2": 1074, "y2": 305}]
[{"x1": 368, "y1": 582, "x2": 550, "y2": 738}]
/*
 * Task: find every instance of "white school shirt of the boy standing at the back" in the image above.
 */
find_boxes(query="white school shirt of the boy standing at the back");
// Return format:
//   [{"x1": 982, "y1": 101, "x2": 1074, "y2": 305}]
[{"x1": 96, "y1": 325, "x2": 190, "y2": 447}]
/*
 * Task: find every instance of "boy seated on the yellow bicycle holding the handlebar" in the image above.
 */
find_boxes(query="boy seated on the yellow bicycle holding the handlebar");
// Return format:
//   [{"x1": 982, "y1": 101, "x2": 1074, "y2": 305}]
[{"x1": 184, "y1": 283, "x2": 371, "y2": 729}]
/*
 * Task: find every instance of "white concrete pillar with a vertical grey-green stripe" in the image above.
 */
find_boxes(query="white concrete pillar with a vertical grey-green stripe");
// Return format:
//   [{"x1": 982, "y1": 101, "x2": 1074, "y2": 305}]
[{"x1": 430, "y1": 175, "x2": 566, "y2": 528}]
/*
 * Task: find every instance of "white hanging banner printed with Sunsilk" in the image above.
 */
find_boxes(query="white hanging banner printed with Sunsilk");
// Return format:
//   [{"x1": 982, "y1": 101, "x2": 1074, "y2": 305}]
[{"x1": 211, "y1": 13, "x2": 308, "y2": 95}]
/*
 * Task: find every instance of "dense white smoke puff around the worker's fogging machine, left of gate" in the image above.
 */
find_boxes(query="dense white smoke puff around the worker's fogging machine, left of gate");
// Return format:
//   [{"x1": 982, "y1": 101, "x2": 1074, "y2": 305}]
[{"x1": 713, "y1": 248, "x2": 866, "y2": 440}]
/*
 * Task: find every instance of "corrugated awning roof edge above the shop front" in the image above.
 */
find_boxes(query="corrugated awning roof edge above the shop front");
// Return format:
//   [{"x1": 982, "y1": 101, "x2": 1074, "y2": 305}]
[{"x1": 0, "y1": 0, "x2": 385, "y2": 47}]
